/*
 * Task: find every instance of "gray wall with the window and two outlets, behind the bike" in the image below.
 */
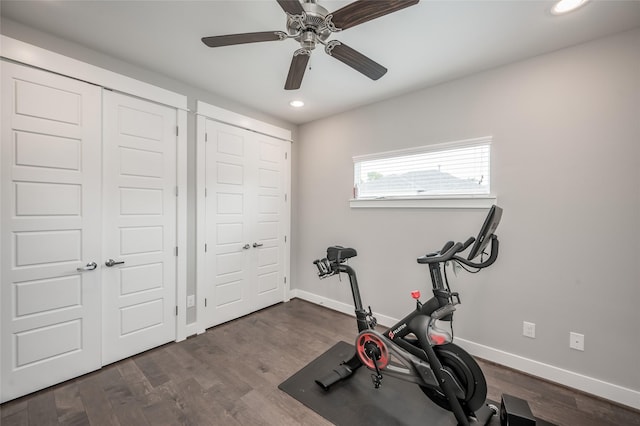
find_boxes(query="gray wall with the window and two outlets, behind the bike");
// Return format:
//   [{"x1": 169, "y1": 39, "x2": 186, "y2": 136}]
[{"x1": 292, "y1": 29, "x2": 640, "y2": 391}]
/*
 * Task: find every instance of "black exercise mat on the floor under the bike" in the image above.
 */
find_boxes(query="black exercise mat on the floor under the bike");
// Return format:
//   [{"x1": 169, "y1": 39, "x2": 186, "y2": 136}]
[{"x1": 278, "y1": 342, "x2": 551, "y2": 426}]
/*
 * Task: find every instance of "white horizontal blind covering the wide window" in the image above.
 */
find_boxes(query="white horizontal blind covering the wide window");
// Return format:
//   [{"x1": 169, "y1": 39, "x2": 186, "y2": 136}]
[{"x1": 353, "y1": 138, "x2": 491, "y2": 199}]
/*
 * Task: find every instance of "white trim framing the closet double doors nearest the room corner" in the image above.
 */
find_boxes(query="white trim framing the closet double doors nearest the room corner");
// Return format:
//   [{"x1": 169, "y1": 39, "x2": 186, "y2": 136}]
[{"x1": 196, "y1": 101, "x2": 291, "y2": 334}]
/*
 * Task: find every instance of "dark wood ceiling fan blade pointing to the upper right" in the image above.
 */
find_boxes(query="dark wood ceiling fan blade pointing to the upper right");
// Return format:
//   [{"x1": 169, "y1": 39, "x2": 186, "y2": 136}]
[{"x1": 330, "y1": 0, "x2": 420, "y2": 30}]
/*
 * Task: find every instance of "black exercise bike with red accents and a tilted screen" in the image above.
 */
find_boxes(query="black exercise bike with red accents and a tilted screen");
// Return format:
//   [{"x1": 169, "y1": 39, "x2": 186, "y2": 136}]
[{"x1": 313, "y1": 205, "x2": 502, "y2": 426}]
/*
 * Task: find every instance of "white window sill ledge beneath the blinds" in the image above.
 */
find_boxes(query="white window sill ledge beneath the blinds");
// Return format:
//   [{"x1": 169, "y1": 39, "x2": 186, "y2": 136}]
[{"x1": 349, "y1": 196, "x2": 498, "y2": 209}]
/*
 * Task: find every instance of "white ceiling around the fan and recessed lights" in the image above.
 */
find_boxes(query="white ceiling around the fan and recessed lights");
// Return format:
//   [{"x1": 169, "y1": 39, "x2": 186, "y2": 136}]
[{"x1": 1, "y1": 0, "x2": 640, "y2": 124}]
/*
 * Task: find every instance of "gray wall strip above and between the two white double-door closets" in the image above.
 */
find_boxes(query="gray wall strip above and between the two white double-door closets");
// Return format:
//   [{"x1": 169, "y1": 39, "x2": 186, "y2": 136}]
[{"x1": 0, "y1": 18, "x2": 297, "y2": 323}]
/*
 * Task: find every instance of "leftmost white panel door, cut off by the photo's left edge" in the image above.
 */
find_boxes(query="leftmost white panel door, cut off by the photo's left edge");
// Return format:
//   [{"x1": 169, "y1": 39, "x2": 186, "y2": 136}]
[{"x1": 0, "y1": 62, "x2": 101, "y2": 401}]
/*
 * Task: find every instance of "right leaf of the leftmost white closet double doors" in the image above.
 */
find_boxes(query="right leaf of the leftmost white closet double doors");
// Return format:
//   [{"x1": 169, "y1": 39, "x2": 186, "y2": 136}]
[{"x1": 102, "y1": 91, "x2": 177, "y2": 364}]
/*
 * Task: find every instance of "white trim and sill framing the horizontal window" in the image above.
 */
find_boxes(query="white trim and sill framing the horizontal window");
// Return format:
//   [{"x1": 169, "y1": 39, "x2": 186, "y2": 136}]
[{"x1": 349, "y1": 136, "x2": 497, "y2": 209}]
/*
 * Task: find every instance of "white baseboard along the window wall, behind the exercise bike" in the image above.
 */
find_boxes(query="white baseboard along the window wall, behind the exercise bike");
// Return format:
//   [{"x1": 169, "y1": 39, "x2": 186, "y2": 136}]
[{"x1": 290, "y1": 289, "x2": 640, "y2": 410}]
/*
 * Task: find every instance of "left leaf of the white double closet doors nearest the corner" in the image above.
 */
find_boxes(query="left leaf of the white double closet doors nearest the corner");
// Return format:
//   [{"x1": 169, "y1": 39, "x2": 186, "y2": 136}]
[{"x1": 205, "y1": 120, "x2": 255, "y2": 326}]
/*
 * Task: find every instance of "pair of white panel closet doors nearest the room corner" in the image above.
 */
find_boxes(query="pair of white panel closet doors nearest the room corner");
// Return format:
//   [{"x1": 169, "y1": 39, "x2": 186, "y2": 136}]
[{"x1": 205, "y1": 120, "x2": 286, "y2": 327}]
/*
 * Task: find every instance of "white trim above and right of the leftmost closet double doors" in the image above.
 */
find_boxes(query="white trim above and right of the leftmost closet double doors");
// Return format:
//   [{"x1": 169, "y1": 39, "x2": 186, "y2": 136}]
[{"x1": 0, "y1": 35, "x2": 189, "y2": 342}]
